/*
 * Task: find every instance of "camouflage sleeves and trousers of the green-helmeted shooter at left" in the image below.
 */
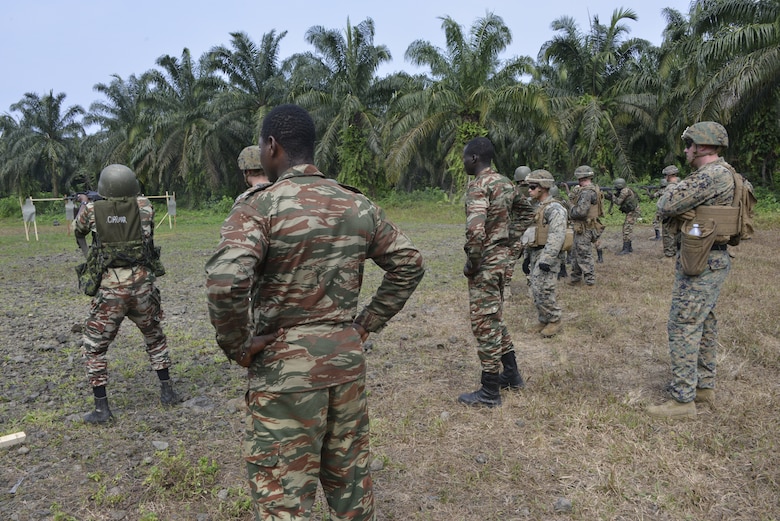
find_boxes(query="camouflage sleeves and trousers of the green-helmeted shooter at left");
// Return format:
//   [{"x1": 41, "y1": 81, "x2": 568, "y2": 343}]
[{"x1": 73, "y1": 197, "x2": 171, "y2": 387}]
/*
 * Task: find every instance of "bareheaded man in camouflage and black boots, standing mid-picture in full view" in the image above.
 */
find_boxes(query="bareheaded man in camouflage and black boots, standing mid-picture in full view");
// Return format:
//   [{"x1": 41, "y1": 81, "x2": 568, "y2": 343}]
[{"x1": 458, "y1": 137, "x2": 524, "y2": 407}]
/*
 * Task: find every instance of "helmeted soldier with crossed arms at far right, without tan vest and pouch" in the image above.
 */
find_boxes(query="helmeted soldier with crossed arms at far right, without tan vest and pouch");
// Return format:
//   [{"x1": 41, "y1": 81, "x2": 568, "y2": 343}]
[{"x1": 648, "y1": 121, "x2": 736, "y2": 418}]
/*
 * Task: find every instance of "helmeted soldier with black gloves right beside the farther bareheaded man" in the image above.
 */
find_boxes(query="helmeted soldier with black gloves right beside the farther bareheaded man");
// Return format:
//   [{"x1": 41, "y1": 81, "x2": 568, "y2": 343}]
[{"x1": 523, "y1": 170, "x2": 568, "y2": 338}]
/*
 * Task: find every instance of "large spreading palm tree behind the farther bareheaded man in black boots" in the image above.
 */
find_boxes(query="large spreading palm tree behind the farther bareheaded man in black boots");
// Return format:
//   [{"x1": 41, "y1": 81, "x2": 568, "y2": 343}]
[{"x1": 388, "y1": 12, "x2": 552, "y2": 192}]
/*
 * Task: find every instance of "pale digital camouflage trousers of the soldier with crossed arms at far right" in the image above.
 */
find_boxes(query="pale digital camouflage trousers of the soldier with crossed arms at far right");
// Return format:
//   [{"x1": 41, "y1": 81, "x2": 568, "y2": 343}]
[{"x1": 666, "y1": 250, "x2": 731, "y2": 402}]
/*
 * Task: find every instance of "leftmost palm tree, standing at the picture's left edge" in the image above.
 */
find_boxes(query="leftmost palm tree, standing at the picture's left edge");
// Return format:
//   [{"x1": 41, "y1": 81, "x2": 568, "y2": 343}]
[{"x1": 0, "y1": 91, "x2": 84, "y2": 197}]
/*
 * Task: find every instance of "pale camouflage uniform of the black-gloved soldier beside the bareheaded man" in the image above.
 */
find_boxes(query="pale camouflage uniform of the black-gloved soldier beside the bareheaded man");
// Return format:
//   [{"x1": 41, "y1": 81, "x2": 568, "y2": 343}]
[{"x1": 527, "y1": 197, "x2": 568, "y2": 324}]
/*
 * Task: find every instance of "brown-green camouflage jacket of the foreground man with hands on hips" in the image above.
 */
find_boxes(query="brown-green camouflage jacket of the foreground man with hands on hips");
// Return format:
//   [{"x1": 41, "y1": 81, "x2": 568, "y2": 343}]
[{"x1": 206, "y1": 165, "x2": 424, "y2": 392}]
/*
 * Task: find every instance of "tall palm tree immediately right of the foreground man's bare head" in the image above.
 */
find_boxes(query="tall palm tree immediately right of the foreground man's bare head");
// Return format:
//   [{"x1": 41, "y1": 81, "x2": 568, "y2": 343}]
[{"x1": 287, "y1": 18, "x2": 391, "y2": 193}]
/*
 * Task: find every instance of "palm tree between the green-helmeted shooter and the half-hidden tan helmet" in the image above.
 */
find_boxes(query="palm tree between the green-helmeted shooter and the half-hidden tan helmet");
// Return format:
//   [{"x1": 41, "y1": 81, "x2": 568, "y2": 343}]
[{"x1": 133, "y1": 48, "x2": 225, "y2": 201}]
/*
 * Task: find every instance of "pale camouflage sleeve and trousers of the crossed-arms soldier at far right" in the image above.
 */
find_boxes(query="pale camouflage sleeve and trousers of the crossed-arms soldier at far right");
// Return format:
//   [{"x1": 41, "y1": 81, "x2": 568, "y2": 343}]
[{"x1": 658, "y1": 158, "x2": 734, "y2": 403}]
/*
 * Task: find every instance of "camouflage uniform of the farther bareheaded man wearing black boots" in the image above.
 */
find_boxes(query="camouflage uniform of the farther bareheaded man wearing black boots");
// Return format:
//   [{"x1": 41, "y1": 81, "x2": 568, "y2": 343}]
[{"x1": 463, "y1": 168, "x2": 516, "y2": 373}]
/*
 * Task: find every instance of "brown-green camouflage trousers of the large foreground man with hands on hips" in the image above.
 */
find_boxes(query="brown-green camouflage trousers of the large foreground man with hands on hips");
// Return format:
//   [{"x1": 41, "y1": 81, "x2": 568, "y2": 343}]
[{"x1": 243, "y1": 378, "x2": 375, "y2": 521}]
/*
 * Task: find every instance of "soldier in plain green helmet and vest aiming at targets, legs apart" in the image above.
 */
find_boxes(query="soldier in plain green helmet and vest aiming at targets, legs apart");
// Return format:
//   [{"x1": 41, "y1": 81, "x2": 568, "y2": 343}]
[{"x1": 73, "y1": 165, "x2": 179, "y2": 423}]
